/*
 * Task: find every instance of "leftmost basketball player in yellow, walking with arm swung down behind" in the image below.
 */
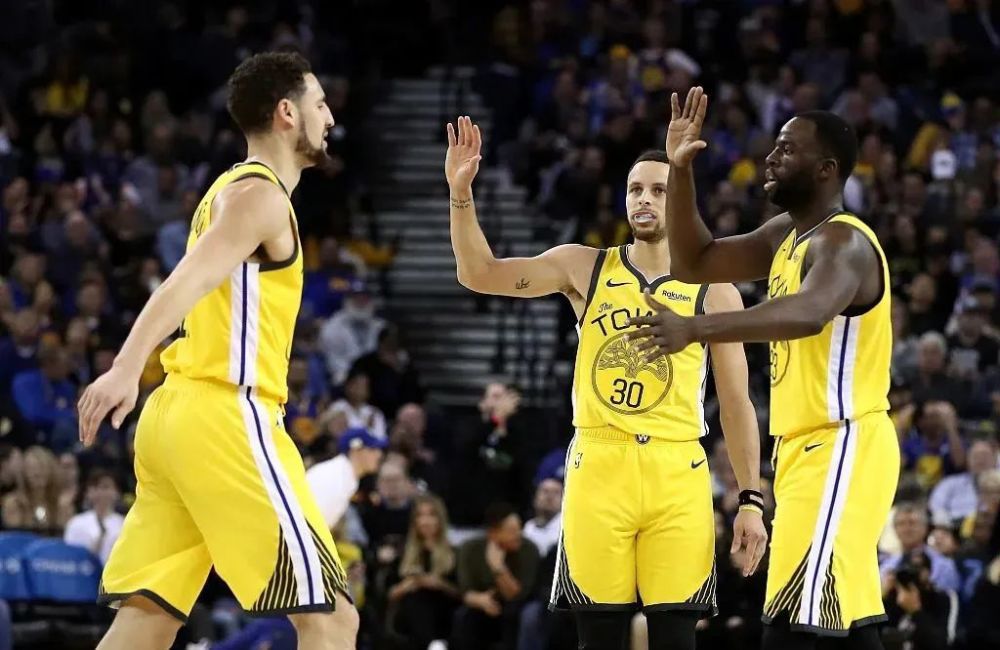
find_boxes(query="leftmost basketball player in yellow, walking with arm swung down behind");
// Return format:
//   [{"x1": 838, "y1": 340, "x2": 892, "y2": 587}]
[{"x1": 79, "y1": 53, "x2": 357, "y2": 650}]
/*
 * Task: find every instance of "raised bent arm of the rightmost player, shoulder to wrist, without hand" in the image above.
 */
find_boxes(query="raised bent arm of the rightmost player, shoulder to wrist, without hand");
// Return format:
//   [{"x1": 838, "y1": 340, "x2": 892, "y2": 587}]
[{"x1": 667, "y1": 159, "x2": 792, "y2": 283}]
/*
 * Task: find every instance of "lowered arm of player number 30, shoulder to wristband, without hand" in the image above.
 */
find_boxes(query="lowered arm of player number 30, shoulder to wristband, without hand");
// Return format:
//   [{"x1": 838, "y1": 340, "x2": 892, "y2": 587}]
[{"x1": 705, "y1": 284, "x2": 760, "y2": 491}]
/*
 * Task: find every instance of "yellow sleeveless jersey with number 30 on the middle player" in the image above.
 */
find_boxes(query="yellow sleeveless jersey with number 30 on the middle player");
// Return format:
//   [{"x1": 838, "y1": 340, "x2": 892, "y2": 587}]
[{"x1": 573, "y1": 246, "x2": 708, "y2": 441}]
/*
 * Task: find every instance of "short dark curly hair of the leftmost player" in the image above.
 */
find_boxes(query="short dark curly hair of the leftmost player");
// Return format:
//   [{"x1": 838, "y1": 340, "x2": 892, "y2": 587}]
[{"x1": 226, "y1": 52, "x2": 312, "y2": 135}]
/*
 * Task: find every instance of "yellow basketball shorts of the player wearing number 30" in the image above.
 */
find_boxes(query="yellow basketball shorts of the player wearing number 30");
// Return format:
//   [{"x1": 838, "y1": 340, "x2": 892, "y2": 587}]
[{"x1": 550, "y1": 428, "x2": 716, "y2": 614}]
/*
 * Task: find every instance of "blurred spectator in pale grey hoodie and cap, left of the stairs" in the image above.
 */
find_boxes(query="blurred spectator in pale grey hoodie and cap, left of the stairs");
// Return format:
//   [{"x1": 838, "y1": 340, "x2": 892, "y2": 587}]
[{"x1": 319, "y1": 280, "x2": 385, "y2": 386}]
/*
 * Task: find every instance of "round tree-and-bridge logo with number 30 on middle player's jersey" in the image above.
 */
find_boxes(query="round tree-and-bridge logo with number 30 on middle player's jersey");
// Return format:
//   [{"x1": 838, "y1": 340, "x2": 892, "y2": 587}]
[{"x1": 591, "y1": 332, "x2": 674, "y2": 415}]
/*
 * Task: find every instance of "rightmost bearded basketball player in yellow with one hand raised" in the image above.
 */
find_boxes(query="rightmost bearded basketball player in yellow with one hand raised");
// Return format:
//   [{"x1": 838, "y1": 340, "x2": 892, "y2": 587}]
[{"x1": 632, "y1": 88, "x2": 899, "y2": 650}]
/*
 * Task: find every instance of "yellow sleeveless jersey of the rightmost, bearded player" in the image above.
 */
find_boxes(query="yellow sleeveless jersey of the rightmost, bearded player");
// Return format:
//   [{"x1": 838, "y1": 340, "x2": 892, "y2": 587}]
[{"x1": 768, "y1": 212, "x2": 892, "y2": 436}]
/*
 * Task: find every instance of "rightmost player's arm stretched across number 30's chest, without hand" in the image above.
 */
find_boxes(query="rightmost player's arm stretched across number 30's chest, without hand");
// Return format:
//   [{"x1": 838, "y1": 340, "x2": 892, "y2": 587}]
[{"x1": 692, "y1": 223, "x2": 878, "y2": 343}]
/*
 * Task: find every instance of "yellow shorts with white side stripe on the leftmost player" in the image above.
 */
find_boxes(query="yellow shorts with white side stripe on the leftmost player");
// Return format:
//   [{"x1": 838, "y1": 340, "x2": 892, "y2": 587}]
[{"x1": 98, "y1": 375, "x2": 348, "y2": 621}]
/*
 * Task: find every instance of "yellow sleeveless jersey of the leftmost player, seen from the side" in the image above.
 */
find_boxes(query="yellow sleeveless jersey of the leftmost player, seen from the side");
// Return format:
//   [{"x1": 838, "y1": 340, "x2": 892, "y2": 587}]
[{"x1": 160, "y1": 162, "x2": 302, "y2": 403}]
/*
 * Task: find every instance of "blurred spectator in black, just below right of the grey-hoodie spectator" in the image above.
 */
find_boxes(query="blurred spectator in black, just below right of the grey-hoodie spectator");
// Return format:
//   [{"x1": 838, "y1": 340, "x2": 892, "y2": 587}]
[{"x1": 352, "y1": 323, "x2": 424, "y2": 413}]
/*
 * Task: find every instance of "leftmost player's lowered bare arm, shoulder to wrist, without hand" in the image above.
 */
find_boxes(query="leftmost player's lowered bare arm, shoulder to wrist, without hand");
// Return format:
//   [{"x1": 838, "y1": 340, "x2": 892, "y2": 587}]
[{"x1": 115, "y1": 179, "x2": 288, "y2": 376}]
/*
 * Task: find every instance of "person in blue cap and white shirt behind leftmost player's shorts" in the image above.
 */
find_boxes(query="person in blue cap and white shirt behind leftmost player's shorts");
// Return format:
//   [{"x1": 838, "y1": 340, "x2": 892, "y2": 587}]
[{"x1": 306, "y1": 427, "x2": 388, "y2": 528}]
